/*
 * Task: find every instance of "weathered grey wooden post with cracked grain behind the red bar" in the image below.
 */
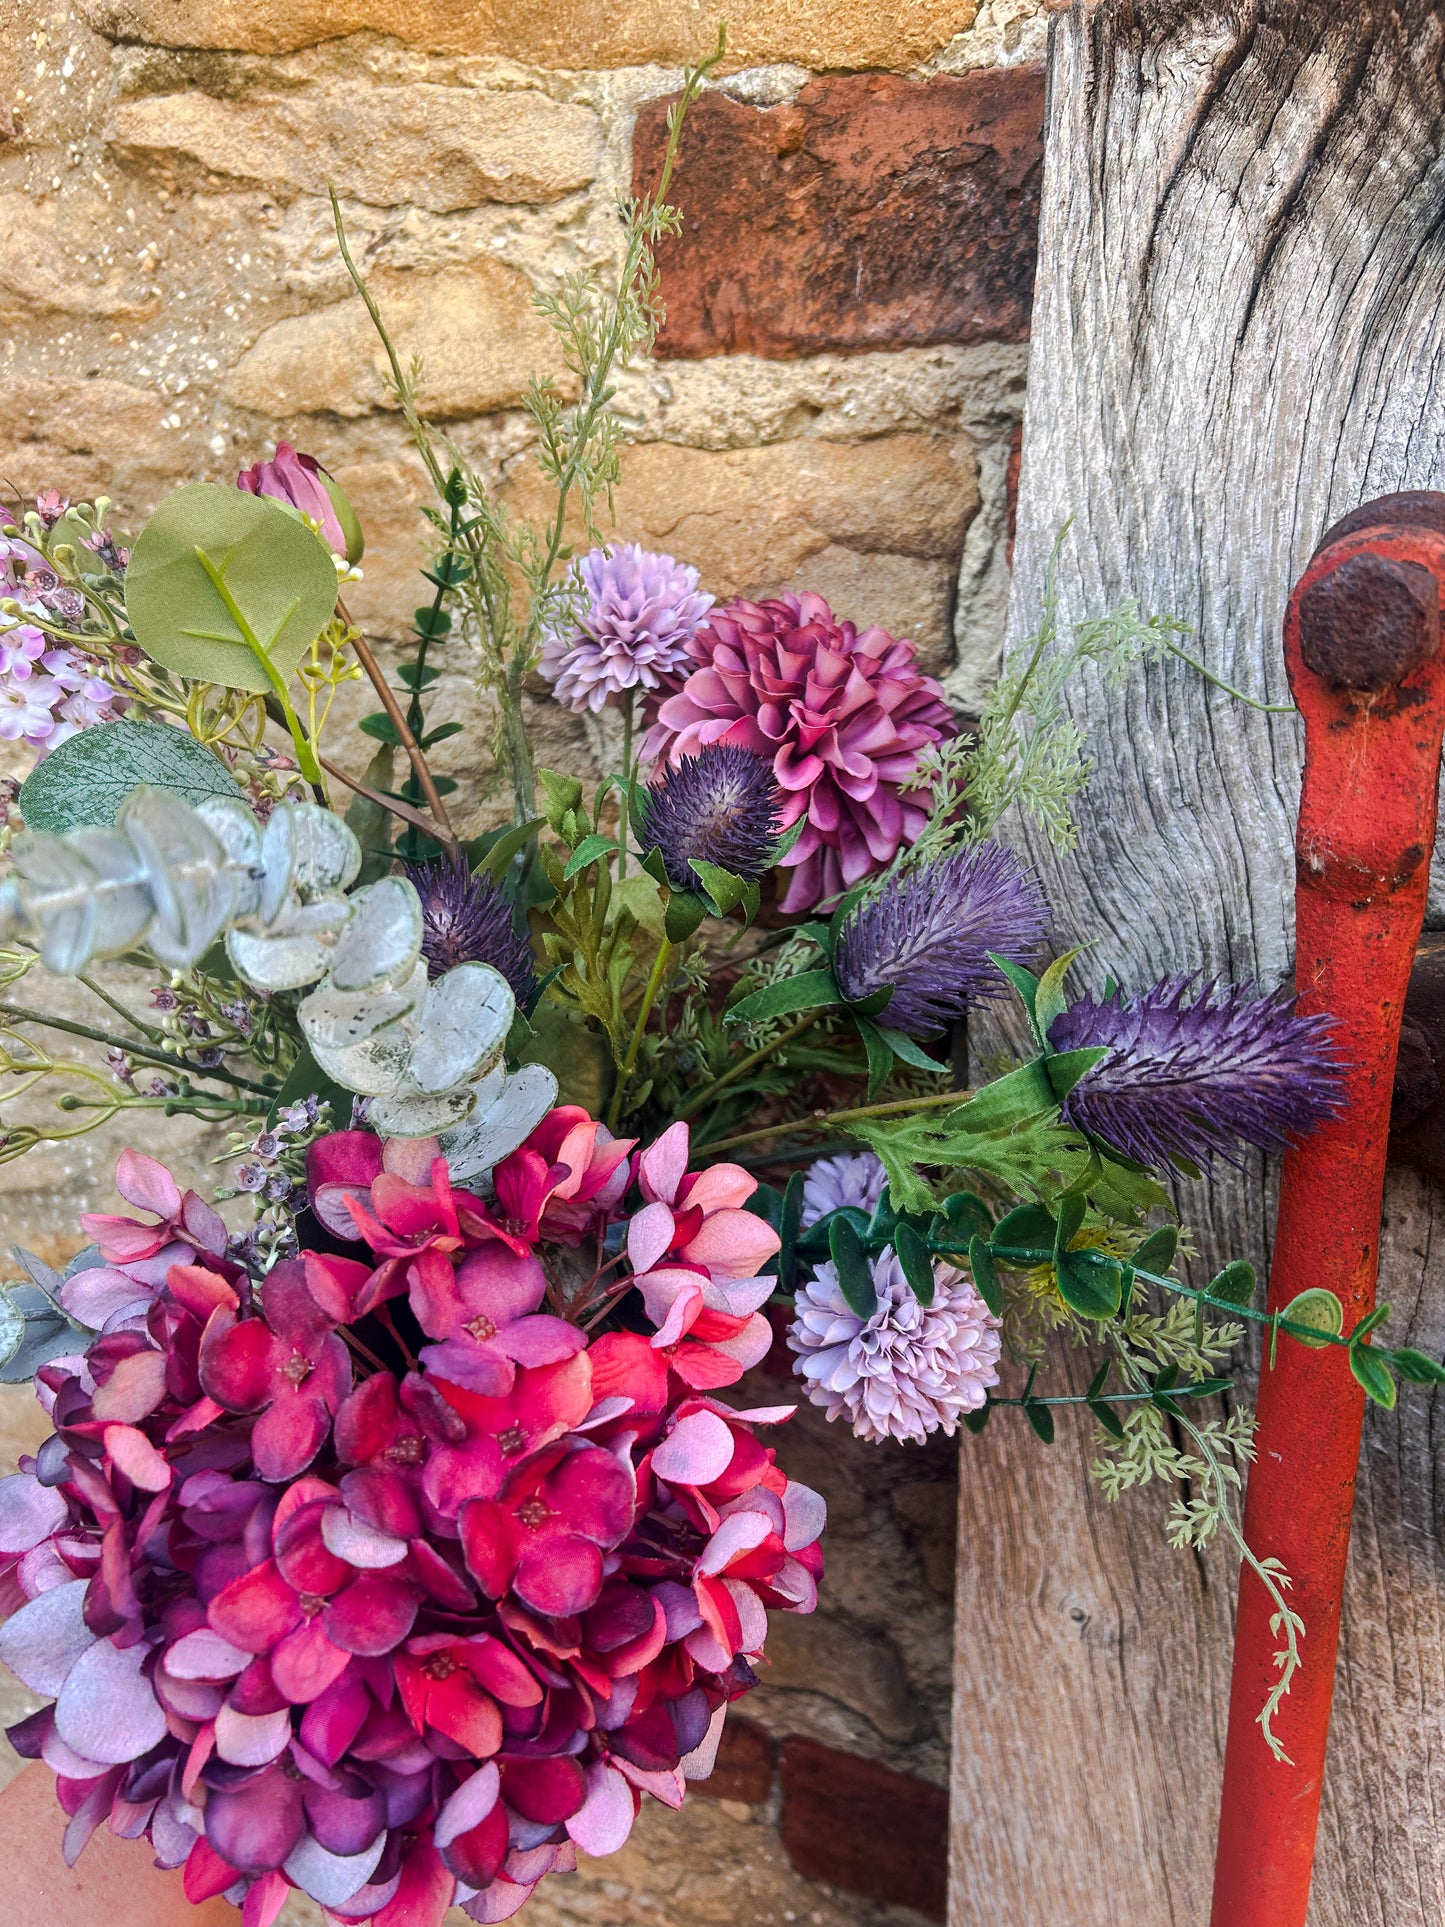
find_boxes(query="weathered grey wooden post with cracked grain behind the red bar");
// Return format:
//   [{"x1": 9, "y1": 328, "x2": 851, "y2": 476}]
[{"x1": 952, "y1": 0, "x2": 1445, "y2": 1927}]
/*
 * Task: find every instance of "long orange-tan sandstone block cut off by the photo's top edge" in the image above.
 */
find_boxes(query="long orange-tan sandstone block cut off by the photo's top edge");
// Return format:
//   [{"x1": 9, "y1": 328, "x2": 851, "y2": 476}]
[{"x1": 79, "y1": 0, "x2": 979, "y2": 71}]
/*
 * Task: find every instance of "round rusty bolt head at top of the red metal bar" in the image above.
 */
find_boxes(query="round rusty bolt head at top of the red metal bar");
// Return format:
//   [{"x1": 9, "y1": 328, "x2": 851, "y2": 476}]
[{"x1": 1299, "y1": 553, "x2": 1439, "y2": 690}]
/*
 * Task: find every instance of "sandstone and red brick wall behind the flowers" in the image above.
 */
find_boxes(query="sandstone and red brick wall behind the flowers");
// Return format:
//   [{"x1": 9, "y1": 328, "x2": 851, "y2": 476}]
[{"x1": 0, "y1": 0, "x2": 1042, "y2": 1927}]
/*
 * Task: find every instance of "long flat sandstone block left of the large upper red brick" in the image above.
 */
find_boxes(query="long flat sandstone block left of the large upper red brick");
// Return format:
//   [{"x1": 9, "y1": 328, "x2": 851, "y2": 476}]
[{"x1": 108, "y1": 81, "x2": 601, "y2": 214}]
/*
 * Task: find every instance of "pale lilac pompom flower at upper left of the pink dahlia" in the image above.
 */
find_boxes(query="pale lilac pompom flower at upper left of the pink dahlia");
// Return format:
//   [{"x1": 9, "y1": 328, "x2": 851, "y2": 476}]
[{"x1": 538, "y1": 541, "x2": 713, "y2": 715}]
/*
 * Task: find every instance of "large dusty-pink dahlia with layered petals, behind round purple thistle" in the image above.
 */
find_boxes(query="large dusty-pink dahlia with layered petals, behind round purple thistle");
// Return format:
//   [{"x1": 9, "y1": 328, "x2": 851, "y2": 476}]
[{"x1": 647, "y1": 594, "x2": 956, "y2": 911}]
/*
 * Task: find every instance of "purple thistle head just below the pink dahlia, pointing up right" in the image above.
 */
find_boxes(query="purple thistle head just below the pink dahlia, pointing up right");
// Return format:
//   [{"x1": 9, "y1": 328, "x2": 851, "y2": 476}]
[{"x1": 832, "y1": 844, "x2": 1046, "y2": 1037}]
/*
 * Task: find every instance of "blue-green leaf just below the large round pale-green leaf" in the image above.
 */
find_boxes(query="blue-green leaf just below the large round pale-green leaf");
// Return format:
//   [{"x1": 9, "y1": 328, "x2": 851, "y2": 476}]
[{"x1": 19, "y1": 712, "x2": 241, "y2": 836}]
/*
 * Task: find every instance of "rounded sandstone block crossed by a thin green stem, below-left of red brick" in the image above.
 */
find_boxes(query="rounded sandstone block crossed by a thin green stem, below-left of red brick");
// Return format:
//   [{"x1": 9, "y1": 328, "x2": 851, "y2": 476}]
[{"x1": 225, "y1": 258, "x2": 557, "y2": 420}]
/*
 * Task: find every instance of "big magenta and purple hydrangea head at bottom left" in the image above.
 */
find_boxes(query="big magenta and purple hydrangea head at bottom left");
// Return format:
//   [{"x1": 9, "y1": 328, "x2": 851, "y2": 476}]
[{"x1": 0, "y1": 1108, "x2": 823, "y2": 1927}]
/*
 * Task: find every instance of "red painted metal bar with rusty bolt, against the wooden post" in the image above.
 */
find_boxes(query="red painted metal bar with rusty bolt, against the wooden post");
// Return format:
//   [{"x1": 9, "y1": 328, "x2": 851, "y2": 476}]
[{"x1": 1212, "y1": 495, "x2": 1445, "y2": 1927}]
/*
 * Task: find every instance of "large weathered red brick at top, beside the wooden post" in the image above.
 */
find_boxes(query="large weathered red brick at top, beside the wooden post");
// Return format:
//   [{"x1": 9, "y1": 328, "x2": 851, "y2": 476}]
[{"x1": 632, "y1": 67, "x2": 1044, "y2": 358}]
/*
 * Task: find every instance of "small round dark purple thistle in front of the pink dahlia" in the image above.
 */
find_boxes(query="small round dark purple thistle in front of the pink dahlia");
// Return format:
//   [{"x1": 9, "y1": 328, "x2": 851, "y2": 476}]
[{"x1": 638, "y1": 744, "x2": 782, "y2": 890}]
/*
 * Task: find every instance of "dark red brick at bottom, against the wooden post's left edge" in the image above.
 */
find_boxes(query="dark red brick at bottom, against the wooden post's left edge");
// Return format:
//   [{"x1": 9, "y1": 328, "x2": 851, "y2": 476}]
[{"x1": 782, "y1": 1738, "x2": 948, "y2": 1921}]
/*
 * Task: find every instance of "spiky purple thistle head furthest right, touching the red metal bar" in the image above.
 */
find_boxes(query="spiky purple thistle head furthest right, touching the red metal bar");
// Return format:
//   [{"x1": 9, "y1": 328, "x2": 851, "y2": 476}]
[{"x1": 1048, "y1": 977, "x2": 1343, "y2": 1170}]
